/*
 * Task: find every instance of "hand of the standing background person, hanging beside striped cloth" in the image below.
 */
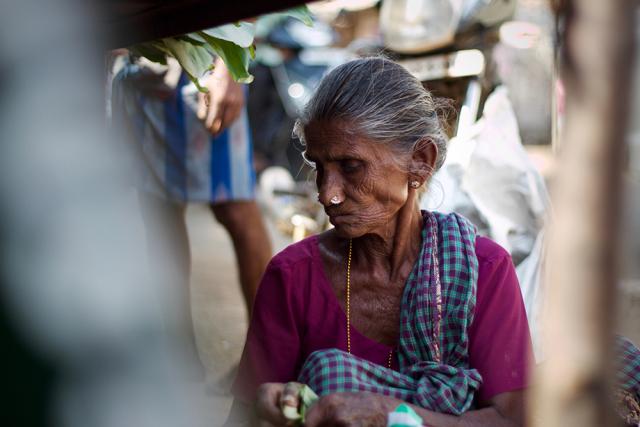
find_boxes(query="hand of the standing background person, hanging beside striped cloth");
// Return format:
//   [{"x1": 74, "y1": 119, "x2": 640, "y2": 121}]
[{"x1": 198, "y1": 58, "x2": 244, "y2": 136}]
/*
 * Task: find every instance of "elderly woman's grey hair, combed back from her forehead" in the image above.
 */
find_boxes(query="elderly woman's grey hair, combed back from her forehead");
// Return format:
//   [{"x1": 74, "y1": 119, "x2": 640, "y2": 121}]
[{"x1": 294, "y1": 57, "x2": 448, "y2": 172}]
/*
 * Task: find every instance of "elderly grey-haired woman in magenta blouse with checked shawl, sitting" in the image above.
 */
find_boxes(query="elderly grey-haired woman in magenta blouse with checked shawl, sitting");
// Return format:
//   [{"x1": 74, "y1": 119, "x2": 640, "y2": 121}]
[{"x1": 232, "y1": 58, "x2": 531, "y2": 426}]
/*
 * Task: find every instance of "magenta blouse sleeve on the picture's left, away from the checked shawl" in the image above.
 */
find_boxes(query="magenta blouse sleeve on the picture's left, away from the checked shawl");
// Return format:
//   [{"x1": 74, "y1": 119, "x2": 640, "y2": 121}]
[{"x1": 232, "y1": 259, "x2": 303, "y2": 403}]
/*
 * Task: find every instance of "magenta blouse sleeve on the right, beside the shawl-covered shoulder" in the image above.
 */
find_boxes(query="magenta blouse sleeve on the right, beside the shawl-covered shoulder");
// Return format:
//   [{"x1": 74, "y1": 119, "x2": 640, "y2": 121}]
[{"x1": 469, "y1": 239, "x2": 533, "y2": 405}]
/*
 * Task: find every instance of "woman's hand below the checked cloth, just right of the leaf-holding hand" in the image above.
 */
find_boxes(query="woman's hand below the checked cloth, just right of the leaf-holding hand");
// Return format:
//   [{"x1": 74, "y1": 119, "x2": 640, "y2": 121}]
[{"x1": 304, "y1": 393, "x2": 389, "y2": 427}]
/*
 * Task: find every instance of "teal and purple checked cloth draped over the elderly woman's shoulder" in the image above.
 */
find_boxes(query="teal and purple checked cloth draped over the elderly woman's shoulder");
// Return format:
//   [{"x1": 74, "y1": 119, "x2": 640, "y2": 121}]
[{"x1": 298, "y1": 211, "x2": 482, "y2": 415}]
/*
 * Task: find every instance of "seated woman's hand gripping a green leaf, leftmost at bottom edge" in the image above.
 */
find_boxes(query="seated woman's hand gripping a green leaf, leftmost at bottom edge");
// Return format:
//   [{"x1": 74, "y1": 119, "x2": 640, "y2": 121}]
[{"x1": 255, "y1": 382, "x2": 302, "y2": 427}]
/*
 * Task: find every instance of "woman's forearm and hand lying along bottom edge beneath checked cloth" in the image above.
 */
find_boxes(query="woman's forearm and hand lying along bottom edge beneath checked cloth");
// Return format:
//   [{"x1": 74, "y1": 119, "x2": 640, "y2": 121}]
[{"x1": 305, "y1": 391, "x2": 524, "y2": 427}]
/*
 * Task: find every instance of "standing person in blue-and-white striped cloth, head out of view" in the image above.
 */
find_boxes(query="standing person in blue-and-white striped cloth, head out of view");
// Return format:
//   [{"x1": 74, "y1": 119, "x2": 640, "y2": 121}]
[{"x1": 112, "y1": 54, "x2": 271, "y2": 377}]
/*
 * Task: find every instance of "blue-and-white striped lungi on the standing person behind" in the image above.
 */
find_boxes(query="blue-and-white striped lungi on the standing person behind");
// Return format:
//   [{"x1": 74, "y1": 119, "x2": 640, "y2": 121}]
[{"x1": 112, "y1": 63, "x2": 255, "y2": 204}]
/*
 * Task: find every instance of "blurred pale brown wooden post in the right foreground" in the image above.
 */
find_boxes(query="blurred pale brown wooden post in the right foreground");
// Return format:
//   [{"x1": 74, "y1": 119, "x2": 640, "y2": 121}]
[{"x1": 529, "y1": 0, "x2": 636, "y2": 427}]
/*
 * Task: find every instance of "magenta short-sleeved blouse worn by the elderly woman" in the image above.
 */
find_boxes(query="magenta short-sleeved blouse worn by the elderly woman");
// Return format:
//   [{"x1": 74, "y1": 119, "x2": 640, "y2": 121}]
[{"x1": 233, "y1": 236, "x2": 533, "y2": 403}]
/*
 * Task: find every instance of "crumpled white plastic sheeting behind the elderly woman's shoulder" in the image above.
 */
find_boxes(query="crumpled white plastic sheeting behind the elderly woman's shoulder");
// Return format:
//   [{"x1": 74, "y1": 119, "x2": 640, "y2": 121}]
[{"x1": 421, "y1": 86, "x2": 550, "y2": 360}]
